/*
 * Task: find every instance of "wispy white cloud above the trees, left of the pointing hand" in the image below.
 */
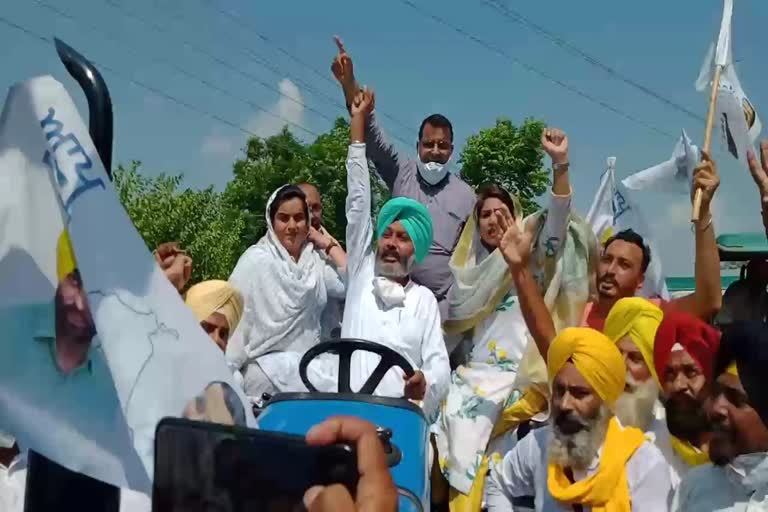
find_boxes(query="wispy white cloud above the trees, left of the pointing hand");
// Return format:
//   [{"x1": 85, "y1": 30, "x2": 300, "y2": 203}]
[{"x1": 200, "y1": 78, "x2": 304, "y2": 159}]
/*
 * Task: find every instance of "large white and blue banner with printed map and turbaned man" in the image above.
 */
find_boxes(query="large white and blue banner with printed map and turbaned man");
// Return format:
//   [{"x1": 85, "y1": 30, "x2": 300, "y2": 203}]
[{"x1": 0, "y1": 77, "x2": 254, "y2": 492}]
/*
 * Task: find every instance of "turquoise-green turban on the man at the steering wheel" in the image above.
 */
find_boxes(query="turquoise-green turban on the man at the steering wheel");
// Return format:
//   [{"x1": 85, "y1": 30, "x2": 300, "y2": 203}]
[{"x1": 376, "y1": 197, "x2": 432, "y2": 263}]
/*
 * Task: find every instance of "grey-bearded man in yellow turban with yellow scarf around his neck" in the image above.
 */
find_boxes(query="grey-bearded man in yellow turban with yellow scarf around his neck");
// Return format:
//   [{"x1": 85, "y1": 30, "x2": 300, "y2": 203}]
[{"x1": 486, "y1": 328, "x2": 671, "y2": 512}]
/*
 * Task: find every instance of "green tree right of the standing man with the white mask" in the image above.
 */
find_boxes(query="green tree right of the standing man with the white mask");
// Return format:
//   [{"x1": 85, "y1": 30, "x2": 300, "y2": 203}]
[{"x1": 459, "y1": 119, "x2": 549, "y2": 215}]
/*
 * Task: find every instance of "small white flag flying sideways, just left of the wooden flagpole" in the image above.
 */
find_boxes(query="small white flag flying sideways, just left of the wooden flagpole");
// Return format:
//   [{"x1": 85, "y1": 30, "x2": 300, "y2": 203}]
[{"x1": 621, "y1": 130, "x2": 699, "y2": 194}]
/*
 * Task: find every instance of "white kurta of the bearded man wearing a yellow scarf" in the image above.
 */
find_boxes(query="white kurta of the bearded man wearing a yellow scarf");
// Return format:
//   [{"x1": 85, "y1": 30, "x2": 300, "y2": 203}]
[{"x1": 485, "y1": 426, "x2": 672, "y2": 512}]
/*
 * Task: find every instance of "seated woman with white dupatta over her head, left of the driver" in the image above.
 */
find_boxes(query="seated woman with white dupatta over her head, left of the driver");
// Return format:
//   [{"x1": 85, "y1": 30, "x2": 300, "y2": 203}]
[{"x1": 227, "y1": 185, "x2": 345, "y2": 402}]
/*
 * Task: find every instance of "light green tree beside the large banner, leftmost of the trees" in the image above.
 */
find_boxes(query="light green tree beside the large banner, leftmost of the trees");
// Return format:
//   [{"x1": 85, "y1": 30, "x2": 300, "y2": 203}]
[{"x1": 114, "y1": 161, "x2": 245, "y2": 283}]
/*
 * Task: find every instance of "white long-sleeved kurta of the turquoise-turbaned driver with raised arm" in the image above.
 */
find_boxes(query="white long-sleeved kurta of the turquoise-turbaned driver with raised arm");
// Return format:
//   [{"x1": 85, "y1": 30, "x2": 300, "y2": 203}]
[{"x1": 341, "y1": 144, "x2": 451, "y2": 418}]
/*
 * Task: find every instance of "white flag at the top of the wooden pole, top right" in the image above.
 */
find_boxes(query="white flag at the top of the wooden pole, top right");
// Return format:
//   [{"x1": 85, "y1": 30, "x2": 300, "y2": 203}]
[{"x1": 696, "y1": 0, "x2": 763, "y2": 162}]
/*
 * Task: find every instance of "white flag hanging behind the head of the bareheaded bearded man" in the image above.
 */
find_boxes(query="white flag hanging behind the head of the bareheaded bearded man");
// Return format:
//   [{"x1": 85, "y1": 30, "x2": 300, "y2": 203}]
[{"x1": 587, "y1": 157, "x2": 669, "y2": 300}]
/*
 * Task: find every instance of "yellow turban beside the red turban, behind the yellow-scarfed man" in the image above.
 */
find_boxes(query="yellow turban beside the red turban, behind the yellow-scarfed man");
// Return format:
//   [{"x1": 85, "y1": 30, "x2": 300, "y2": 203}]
[{"x1": 603, "y1": 297, "x2": 664, "y2": 382}]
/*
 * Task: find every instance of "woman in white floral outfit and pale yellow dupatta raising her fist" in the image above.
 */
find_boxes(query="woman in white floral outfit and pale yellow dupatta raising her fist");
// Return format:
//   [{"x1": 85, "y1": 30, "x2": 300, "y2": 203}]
[{"x1": 432, "y1": 129, "x2": 593, "y2": 504}]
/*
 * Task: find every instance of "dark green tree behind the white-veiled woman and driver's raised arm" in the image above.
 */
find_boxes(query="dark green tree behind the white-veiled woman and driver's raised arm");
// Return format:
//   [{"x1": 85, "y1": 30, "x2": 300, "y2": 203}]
[{"x1": 224, "y1": 118, "x2": 388, "y2": 255}]
